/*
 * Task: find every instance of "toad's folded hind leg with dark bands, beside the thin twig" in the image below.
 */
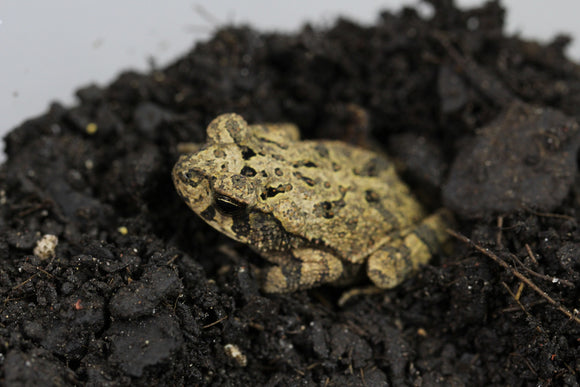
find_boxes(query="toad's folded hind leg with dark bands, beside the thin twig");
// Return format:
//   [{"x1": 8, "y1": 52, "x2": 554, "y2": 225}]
[{"x1": 367, "y1": 210, "x2": 451, "y2": 289}]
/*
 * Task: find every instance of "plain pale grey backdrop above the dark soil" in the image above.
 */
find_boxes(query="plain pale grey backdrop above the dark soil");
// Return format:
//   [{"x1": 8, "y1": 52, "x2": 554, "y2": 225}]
[{"x1": 0, "y1": 0, "x2": 580, "y2": 160}]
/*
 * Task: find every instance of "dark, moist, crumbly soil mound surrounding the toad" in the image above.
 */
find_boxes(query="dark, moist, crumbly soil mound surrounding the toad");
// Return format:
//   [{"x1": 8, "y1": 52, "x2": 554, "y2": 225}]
[{"x1": 0, "y1": 0, "x2": 580, "y2": 386}]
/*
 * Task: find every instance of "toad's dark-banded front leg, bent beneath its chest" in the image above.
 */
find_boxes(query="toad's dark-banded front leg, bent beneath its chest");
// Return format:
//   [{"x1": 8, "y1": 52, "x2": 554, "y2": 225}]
[{"x1": 263, "y1": 249, "x2": 343, "y2": 293}]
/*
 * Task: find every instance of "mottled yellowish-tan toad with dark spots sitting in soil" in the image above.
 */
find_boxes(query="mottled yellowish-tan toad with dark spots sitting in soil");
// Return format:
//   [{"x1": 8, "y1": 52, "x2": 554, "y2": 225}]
[{"x1": 173, "y1": 113, "x2": 447, "y2": 292}]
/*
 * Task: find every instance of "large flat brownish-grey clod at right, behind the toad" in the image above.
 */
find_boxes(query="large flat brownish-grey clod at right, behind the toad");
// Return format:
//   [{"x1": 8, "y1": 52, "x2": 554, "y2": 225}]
[{"x1": 443, "y1": 103, "x2": 580, "y2": 216}]
